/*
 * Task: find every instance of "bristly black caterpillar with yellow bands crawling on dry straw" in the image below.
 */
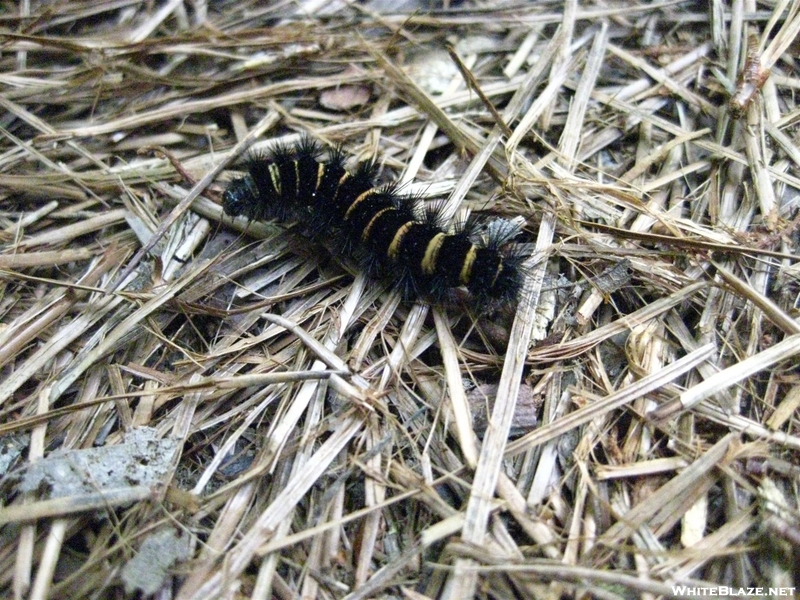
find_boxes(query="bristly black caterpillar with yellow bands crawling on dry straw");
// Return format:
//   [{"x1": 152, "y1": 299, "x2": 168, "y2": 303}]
[{"x1": 222, "y1": 138, "x2": 525, "y2": 306}]
